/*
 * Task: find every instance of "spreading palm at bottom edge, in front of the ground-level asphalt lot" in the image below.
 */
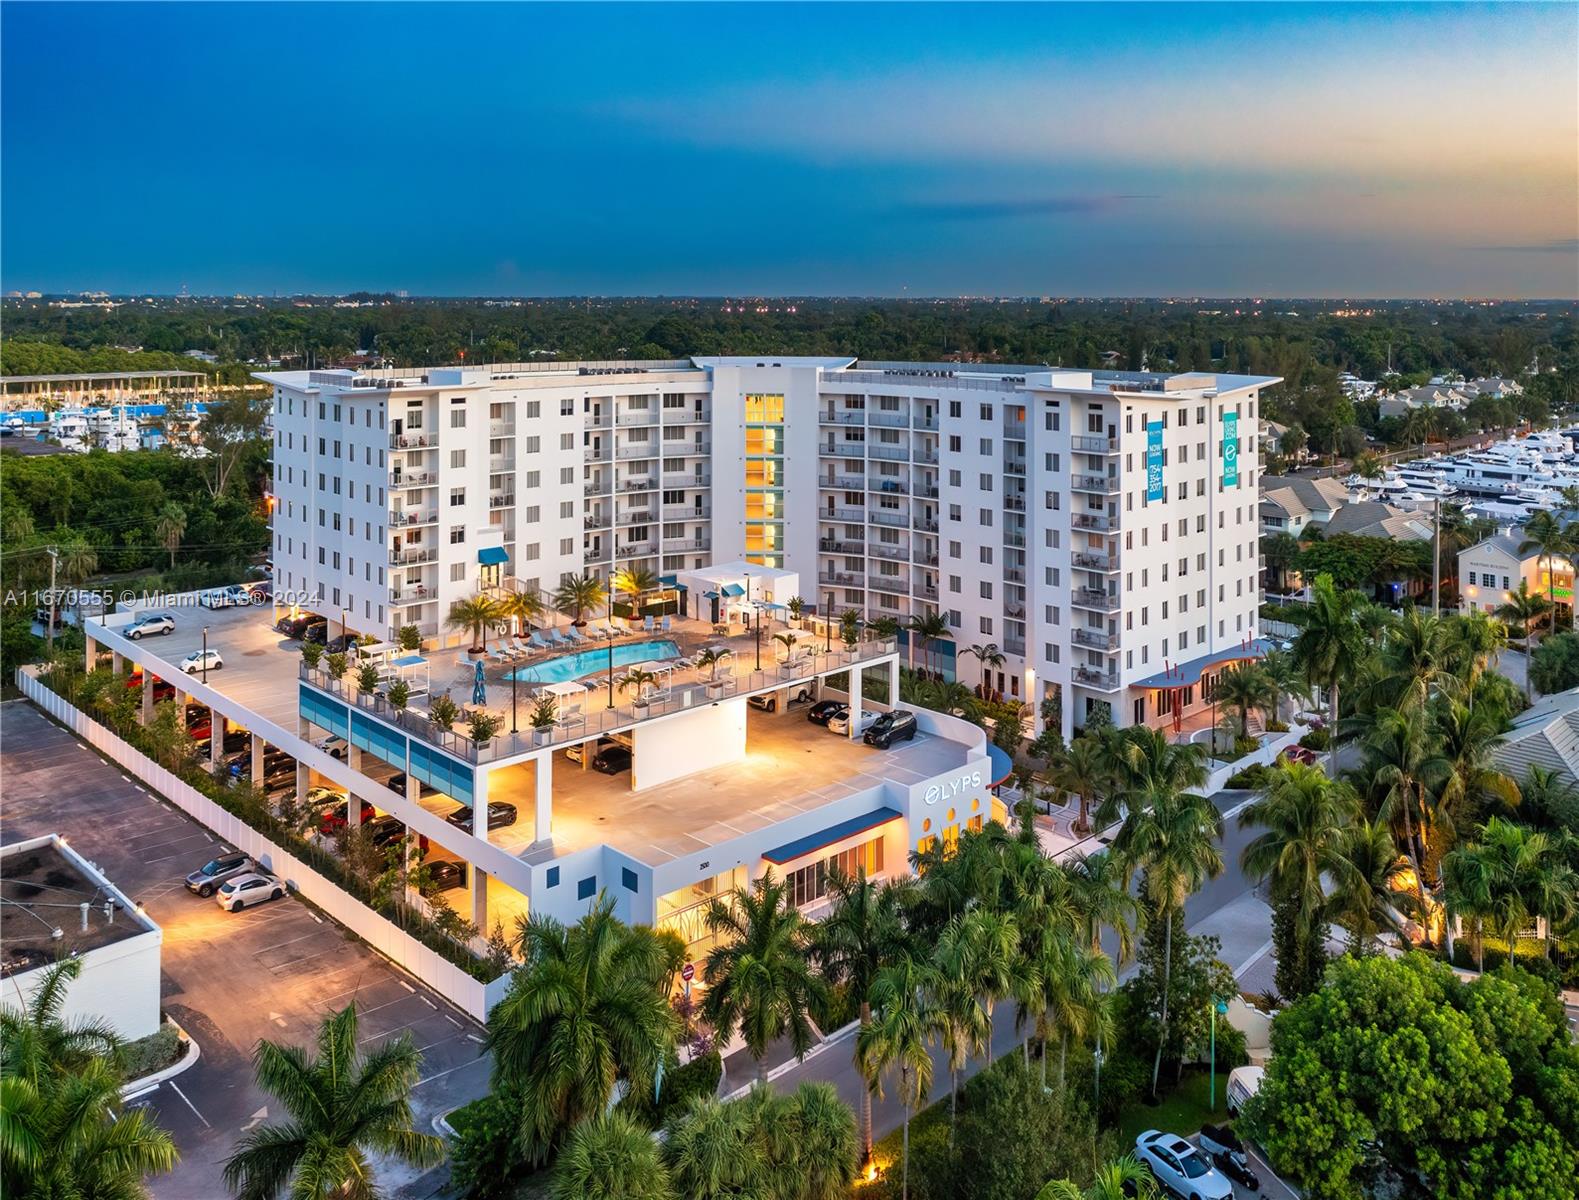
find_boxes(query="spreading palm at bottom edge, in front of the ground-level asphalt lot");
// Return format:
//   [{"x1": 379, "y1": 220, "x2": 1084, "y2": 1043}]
[{"x1": 224, "y1": 1004, "x2": 444, "y2": 1200}]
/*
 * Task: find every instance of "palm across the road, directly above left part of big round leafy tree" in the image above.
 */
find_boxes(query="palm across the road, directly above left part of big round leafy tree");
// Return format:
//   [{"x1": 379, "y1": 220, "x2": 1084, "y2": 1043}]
[{"x1": 1240, "y1": 763, "x2": 1360, "y2": 999}]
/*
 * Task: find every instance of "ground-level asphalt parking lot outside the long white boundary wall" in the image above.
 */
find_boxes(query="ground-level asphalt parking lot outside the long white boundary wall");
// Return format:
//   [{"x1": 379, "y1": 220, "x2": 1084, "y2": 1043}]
[{"x1": 0, "y1": 701, "x2": 488, "y2": 1200}]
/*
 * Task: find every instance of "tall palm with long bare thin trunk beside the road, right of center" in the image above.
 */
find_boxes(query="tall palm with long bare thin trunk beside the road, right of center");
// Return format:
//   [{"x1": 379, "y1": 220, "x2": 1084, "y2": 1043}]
[{"x1": 1113, "y1": 728, "x2": 1222, "y2": 1096}]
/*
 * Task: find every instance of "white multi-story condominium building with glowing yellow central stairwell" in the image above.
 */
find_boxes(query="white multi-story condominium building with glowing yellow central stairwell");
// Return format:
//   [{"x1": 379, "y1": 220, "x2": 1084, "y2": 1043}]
[{"x1": 259, "y1": 355, "x2": 1279, "y2": 736}]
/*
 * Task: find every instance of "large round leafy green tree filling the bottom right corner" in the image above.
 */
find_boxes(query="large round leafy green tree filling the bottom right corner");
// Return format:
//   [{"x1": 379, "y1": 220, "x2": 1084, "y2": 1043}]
[{"x1": 1246, "y1": 954, "x2": 1579, "y2": 1200}]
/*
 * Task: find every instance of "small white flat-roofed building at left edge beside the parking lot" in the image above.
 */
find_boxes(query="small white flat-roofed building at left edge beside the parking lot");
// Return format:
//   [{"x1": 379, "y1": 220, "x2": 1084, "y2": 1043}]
[{"x1": 0, "y1": 834, "x2": 164, "y2": 1041}]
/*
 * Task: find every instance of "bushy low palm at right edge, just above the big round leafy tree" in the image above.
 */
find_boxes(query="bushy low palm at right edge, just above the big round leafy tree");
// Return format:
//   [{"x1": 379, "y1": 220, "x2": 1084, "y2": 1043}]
[{"x1": 1448, "y1": 816, "x2": 1579, "y2": 962}]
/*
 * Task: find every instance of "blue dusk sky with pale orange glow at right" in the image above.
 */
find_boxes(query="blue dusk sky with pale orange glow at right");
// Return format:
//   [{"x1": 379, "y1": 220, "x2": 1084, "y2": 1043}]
[{"x1": 0, "y1": 3, "x2": 1579, "y2": 297}]
